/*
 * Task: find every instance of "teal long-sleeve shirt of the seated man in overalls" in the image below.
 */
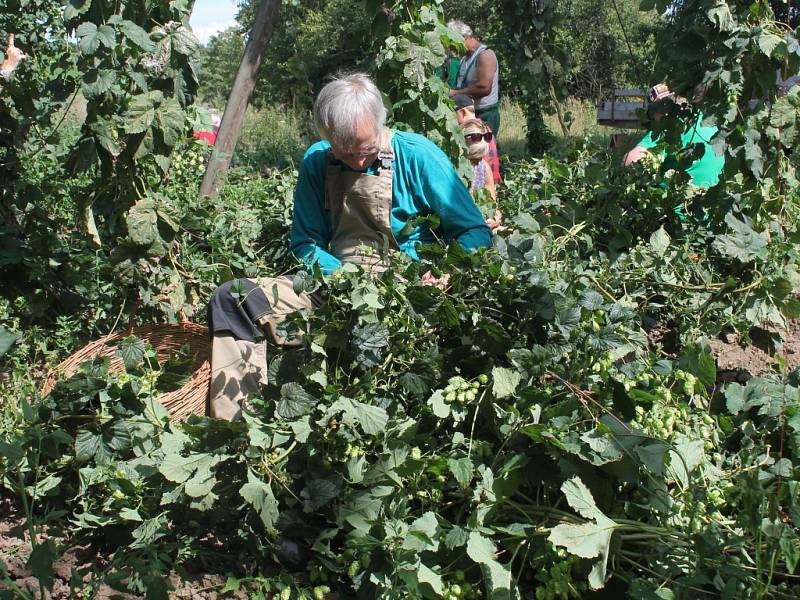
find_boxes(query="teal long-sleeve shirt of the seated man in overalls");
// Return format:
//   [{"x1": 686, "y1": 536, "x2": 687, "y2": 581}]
[{"x1": 291, "y1": 131, "x2": 492, "y2": 273}]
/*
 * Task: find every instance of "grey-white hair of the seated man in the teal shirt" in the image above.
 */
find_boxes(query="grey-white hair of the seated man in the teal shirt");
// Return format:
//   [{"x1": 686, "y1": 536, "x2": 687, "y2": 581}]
[{"x1": 314, "y1": 73, "x2": 386, "y2": 148}]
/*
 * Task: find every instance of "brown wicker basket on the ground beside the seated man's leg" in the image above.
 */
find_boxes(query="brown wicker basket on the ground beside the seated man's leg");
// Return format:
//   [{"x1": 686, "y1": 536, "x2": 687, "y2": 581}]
[{"x1": 42, "y1": 323, "x2": 211, "y2": 421}]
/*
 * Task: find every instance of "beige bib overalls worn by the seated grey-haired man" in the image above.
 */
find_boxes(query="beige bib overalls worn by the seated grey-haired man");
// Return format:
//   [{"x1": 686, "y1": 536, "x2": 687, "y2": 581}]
[{"x1": 209, "y1": 130, "x2": 399, "y2": 420}]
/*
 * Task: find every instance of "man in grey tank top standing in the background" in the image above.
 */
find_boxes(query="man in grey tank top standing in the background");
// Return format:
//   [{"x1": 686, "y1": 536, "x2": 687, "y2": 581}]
[{"x1": 447, "y1": 21, "x2": 500, "y2": 135}]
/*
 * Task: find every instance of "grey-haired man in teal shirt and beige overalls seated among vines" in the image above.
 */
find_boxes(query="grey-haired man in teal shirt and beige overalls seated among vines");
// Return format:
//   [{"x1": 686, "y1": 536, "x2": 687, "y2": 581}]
[{"x1": 203, "y1": 73, "x2": 492, "y2": 420}]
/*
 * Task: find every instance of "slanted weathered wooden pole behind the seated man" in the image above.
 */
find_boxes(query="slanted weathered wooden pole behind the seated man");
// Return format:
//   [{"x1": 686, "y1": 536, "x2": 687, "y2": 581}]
[{"x1": 200, "y1": 0, "x2": 281, "y2": 198}]
